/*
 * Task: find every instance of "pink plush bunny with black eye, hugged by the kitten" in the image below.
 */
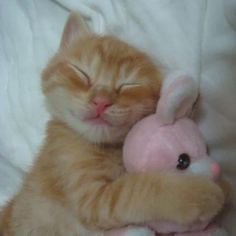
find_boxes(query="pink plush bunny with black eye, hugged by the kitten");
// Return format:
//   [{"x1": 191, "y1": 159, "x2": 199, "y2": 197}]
[{"x1": 107, "y1": 77, "x2": 227, "y2": 236}]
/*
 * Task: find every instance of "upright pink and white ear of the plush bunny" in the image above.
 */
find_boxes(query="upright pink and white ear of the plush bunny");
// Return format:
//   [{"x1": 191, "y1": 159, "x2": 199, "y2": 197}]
[{"x1": 157, "y1": 75, "x2": 198, "y2": 124}]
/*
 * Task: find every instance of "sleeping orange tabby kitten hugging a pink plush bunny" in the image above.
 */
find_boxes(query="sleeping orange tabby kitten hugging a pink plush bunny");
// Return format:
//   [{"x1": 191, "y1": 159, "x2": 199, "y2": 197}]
[{"x1": 0, "y1": 14, "x2": 223, "y2": 236}]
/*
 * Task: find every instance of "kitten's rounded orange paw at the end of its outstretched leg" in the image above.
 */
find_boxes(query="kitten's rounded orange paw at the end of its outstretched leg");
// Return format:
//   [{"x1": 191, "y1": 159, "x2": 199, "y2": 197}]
[{"x1": 161, "y1": 175, "x2": 224, "y2": 224}]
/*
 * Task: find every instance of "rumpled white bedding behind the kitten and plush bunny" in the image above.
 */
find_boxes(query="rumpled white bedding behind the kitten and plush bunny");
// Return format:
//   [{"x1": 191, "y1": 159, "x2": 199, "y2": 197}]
[{"x1": 0, "y1": 0, "x2": 236, "y2": 236}]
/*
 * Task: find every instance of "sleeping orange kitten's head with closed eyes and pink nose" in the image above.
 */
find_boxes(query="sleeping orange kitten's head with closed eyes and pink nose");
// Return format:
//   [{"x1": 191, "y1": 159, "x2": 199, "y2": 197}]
[{"x1": 42, "y1": 14, "x2": 161, "y2": 143}]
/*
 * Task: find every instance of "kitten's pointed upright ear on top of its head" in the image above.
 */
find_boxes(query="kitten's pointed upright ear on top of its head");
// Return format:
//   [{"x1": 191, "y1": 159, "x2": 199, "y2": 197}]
[{"x1": 60, "y1": 12, "x2": 90, "y2": 48}]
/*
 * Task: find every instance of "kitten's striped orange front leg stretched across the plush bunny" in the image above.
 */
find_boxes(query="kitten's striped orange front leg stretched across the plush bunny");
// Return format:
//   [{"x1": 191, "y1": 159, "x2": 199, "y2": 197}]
[{"x1": 63, "y1": 166, "x2": 224, "y2": 230}]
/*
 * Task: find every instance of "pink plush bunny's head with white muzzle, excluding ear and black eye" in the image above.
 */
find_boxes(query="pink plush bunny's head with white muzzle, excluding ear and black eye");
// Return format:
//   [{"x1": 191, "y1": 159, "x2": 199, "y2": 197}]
[{"x1": 123, "y1": 115, "x2": 220, "y2": 179}]
